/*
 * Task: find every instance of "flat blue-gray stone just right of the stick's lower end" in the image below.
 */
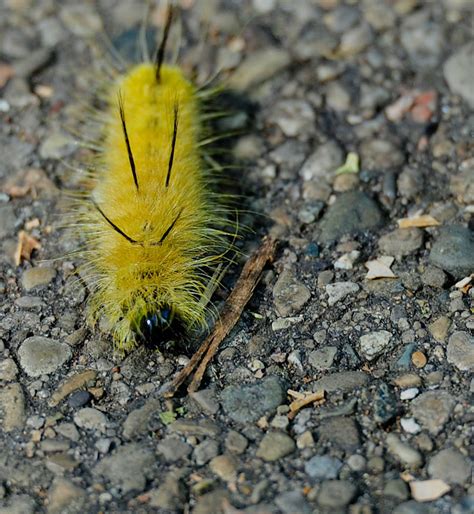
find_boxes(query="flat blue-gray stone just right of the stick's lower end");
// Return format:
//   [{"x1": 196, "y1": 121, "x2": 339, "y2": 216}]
[{"x1": 222, "y1": 376, "x2": 285, "y2": 423}]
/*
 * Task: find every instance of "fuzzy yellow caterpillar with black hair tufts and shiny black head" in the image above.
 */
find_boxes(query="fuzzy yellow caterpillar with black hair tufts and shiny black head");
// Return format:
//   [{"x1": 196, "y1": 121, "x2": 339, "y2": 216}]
[{"x1": 71, "y1": 8, "x2": 229, "y2": 350}]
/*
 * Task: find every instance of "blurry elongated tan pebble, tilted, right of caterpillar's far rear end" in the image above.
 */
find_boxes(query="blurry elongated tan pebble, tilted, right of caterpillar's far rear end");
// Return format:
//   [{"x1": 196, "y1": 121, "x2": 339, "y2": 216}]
[{"x1": 229, "y1": 47, "x2": 292, "y2": 90}]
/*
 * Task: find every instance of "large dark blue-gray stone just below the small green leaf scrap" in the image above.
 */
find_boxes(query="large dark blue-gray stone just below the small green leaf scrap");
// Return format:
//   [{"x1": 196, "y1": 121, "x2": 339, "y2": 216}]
[{"x1": 320, "y1": 191, "x2": 383, "y2": 243}]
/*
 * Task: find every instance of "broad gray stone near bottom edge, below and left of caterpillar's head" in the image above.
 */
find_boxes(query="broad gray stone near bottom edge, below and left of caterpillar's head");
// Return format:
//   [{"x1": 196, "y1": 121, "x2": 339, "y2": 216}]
[{"x1": 92, "y1": 443, "x2": 156, "y2": 494}]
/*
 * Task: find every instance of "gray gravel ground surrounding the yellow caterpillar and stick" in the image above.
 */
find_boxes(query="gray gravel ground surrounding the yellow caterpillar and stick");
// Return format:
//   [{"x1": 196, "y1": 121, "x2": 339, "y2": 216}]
[{"x1": 0, "y1": 0, "x2": 474, "y2": 514}]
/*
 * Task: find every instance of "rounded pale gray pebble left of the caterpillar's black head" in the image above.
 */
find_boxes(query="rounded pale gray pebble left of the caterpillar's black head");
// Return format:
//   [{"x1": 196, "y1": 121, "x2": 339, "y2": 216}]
[{"x1": 18, "y1": 336, "x2": 72, "y2": 377}]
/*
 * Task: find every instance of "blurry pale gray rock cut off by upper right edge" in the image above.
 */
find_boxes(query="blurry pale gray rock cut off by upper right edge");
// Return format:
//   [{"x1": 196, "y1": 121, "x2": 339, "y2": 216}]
[{"x1": 443, "y1": 42, "x2": 474, "y2": 107}]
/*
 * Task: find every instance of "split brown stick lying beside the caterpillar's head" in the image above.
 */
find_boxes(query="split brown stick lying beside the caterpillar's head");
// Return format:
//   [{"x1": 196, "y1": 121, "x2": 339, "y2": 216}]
[{"x1": 164, "y1": 237, "x2": 276, "y2": 398}]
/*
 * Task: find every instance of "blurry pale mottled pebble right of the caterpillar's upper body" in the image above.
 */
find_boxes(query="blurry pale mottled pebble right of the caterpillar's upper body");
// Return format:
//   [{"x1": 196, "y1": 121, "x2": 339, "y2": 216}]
[{"x1": 270, "y1": 100, "x2": 316, "y2": 139}]
